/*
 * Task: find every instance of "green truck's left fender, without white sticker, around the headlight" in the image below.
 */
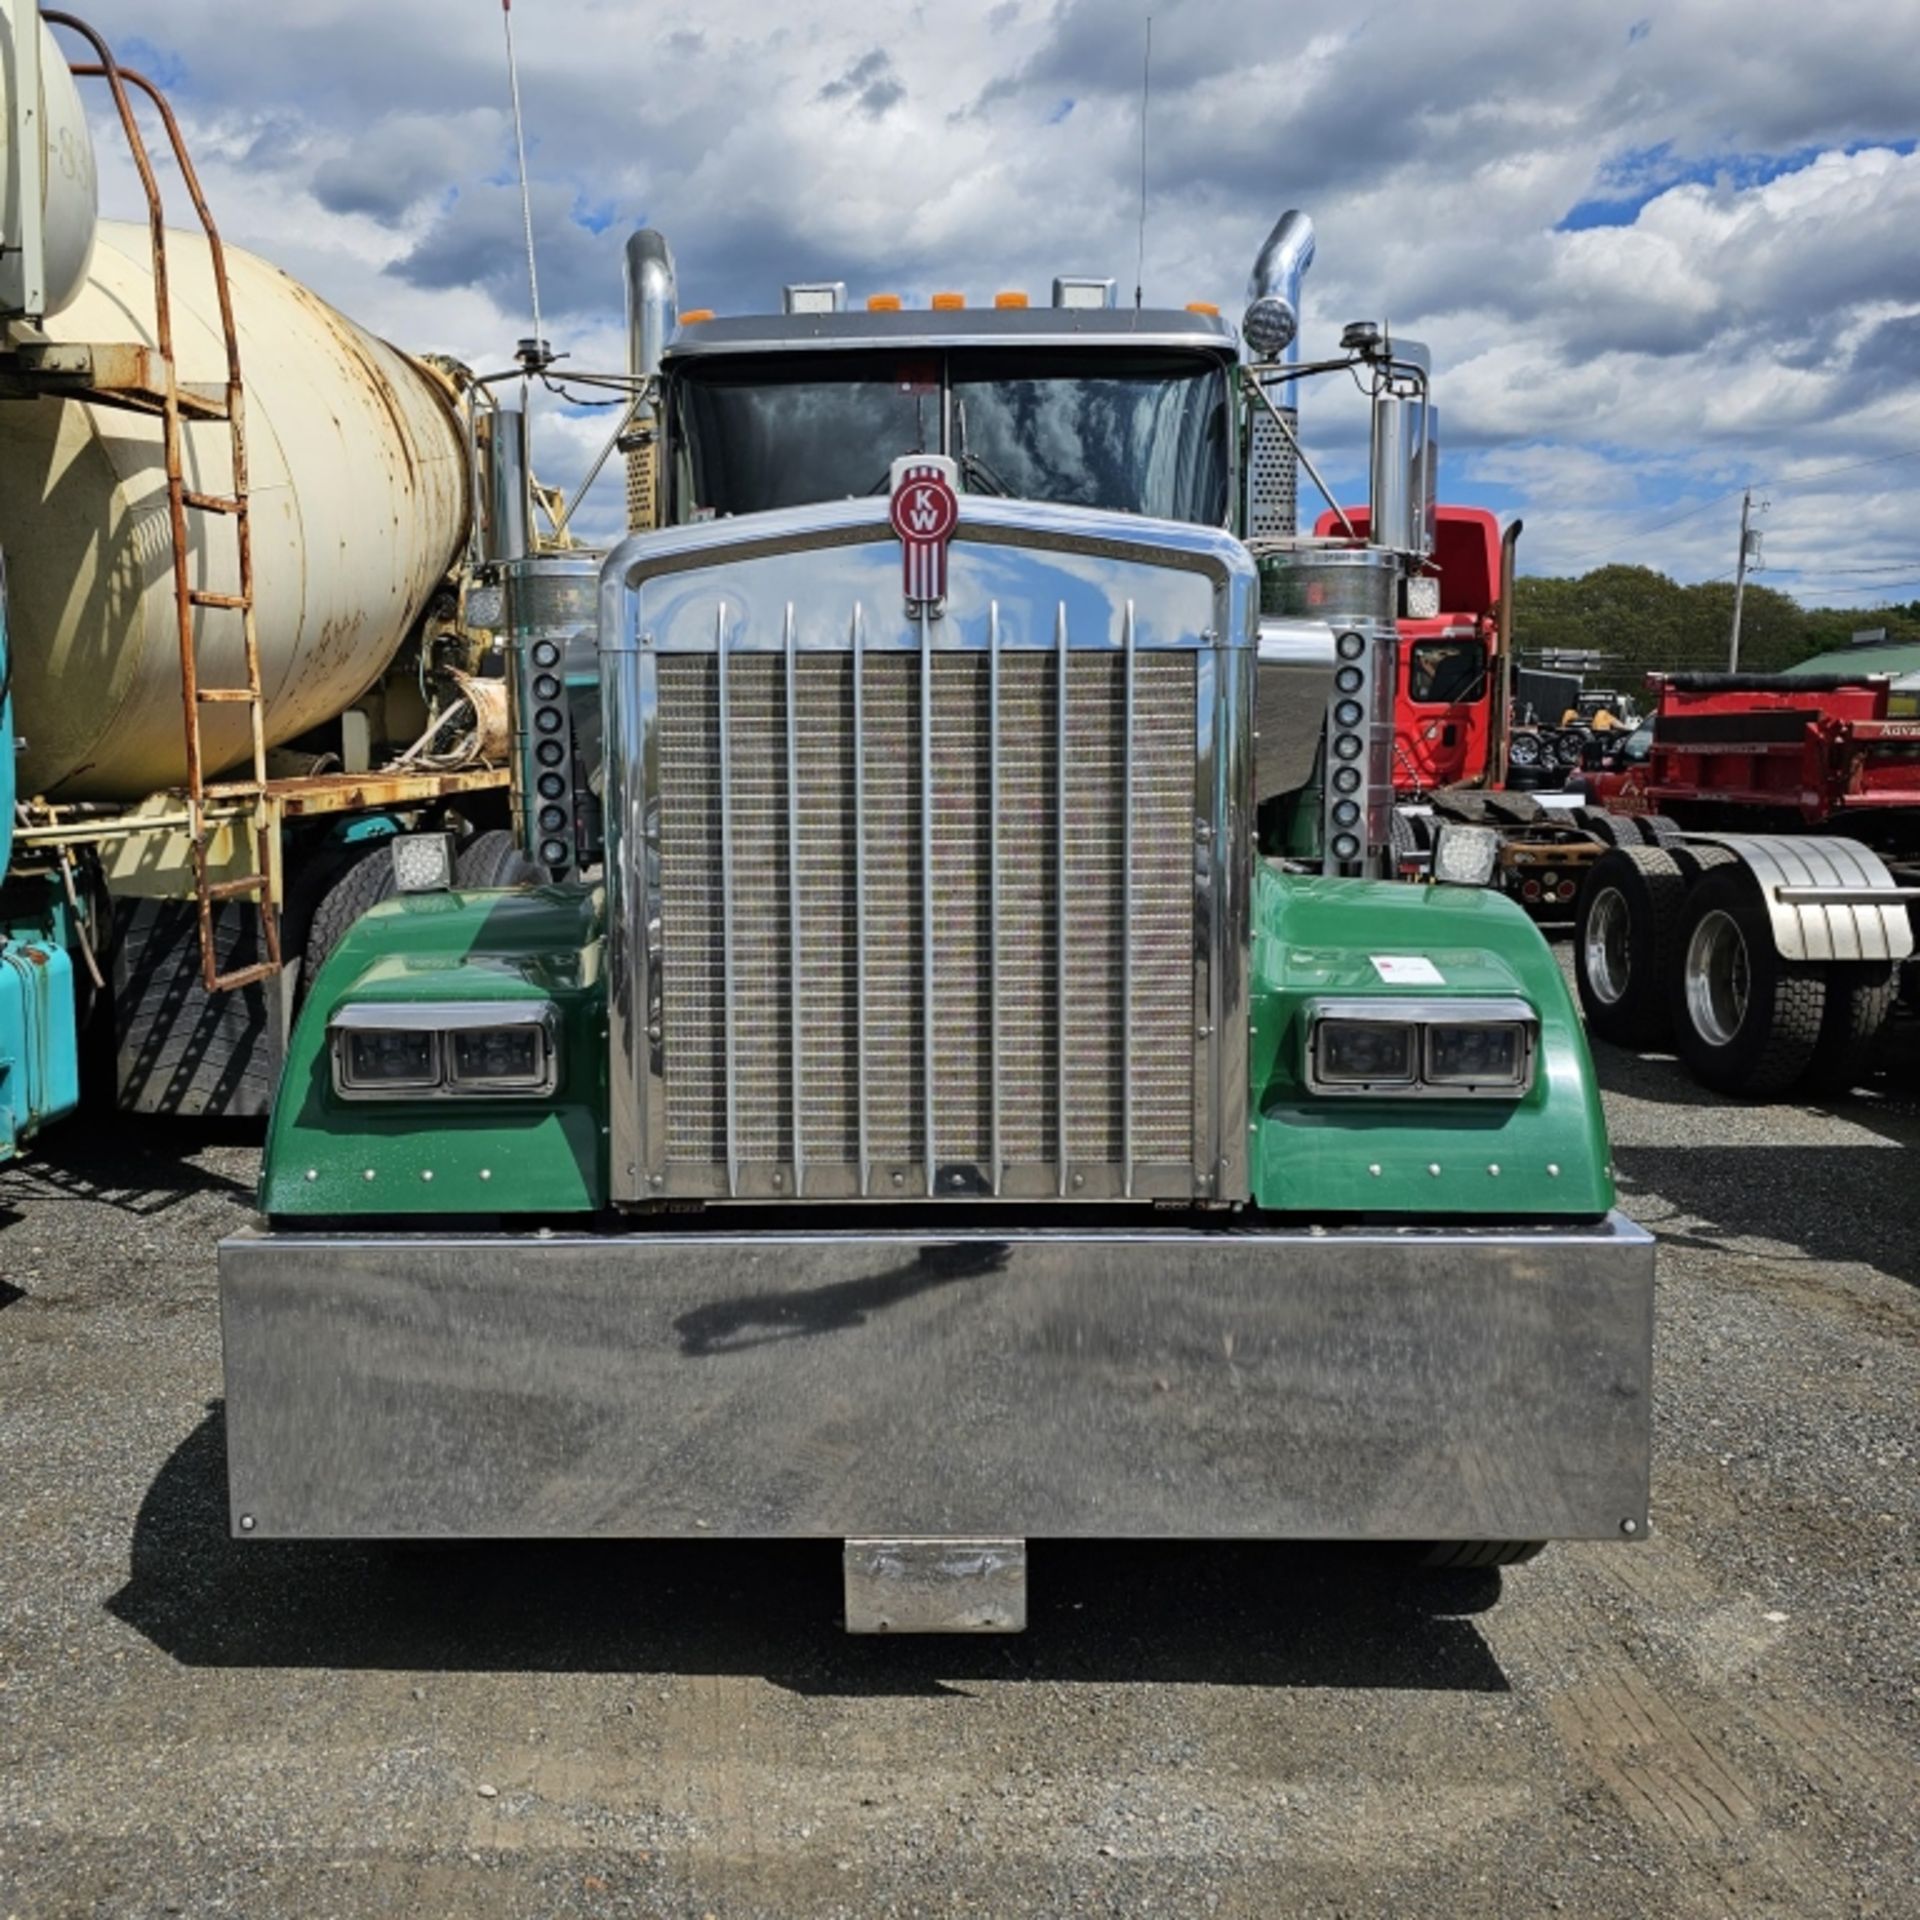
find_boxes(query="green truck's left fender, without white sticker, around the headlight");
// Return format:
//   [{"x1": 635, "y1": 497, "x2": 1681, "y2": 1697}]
[{"x1": 261, "y1": 887, "x2": 607, "y2": 1217}]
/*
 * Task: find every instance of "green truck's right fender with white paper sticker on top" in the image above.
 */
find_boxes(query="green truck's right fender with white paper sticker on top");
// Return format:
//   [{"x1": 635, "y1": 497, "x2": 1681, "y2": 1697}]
[{"x1": 1250, "y1": 866, "x2": 1613, "y2": 1219}]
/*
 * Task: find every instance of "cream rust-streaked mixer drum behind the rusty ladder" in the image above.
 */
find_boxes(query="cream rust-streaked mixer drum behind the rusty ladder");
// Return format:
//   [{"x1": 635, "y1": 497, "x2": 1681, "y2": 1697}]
[{"x1": 0, "y1": 221, "x2": 468, "y2": 801}]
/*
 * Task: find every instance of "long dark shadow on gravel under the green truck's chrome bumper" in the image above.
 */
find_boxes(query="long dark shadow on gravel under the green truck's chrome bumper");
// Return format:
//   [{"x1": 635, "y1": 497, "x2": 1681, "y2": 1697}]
[{"x1": 108, "y1": 1405, "x2": 1526, "y2": 1695}]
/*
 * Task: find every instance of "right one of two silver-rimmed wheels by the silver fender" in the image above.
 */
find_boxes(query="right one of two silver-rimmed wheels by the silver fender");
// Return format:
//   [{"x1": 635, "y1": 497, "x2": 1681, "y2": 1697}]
[{"x1": 1670, "y1": 864, "x2": 1826, "y2": 1098}]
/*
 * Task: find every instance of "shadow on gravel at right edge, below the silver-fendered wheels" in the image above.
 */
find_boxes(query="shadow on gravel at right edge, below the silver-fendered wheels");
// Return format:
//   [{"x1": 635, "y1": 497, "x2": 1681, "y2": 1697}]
[{"x1": 1613, "y1": 1146, "x2": 1920, "y2": 1286}]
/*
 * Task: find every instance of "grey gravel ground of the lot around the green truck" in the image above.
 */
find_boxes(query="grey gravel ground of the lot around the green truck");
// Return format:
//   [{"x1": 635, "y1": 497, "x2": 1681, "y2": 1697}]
[{"x1": 0, "y1": 1006, "x2": 1920, "y2": 1920}]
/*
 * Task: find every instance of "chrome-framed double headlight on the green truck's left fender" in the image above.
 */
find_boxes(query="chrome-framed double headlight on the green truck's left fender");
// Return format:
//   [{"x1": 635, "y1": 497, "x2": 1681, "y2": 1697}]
[{"x1": 328, "y1": 1000, "x2": 561, "y2": 1100}]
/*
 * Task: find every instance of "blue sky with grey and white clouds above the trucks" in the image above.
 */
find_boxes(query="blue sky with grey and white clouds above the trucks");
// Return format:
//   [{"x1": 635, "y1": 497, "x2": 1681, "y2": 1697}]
[{"x1": 52, "y1": 0, "x2": 1920, "y2": 599}]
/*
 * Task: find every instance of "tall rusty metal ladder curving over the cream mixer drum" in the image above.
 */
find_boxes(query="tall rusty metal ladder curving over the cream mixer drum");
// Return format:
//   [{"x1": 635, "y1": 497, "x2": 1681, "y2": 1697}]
[{"x1": 40, "y1": 12, "x2": 280, "y2": 993}]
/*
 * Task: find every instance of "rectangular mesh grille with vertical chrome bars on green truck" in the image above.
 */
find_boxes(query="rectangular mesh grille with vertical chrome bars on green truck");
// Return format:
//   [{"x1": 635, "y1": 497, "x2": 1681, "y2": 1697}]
[{"x1": 653, "y1": 637, "x2": 1208, "y2": 1198}]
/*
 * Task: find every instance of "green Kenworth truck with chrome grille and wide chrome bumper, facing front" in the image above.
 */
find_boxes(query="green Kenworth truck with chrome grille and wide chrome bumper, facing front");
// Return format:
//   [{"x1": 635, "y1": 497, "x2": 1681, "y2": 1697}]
[{"x1": 221, "y1": 213, "x2": 1653, "y2": 1630}]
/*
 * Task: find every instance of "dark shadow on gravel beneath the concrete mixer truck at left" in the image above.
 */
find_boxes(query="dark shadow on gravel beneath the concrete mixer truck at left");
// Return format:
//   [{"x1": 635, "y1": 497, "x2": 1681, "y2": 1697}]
[{"x1": 0, "y1": 1114, "x2": 267, "y2": 1227}]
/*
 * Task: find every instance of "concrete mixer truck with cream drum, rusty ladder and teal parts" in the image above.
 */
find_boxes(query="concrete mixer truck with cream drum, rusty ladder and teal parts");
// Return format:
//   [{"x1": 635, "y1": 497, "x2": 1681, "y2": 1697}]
[{"x1": 0, "y1": 0, "x2": 545, "y2": 1160}]
